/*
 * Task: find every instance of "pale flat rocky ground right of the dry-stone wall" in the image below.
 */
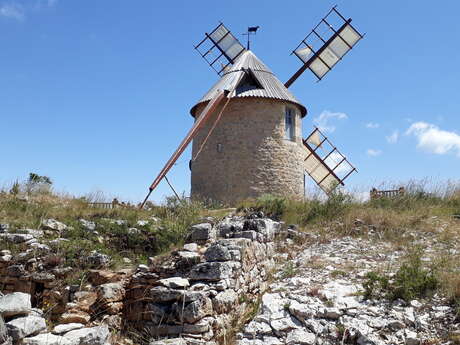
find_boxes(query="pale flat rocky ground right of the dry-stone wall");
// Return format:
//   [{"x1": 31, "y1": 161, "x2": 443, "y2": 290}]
[{"x1": 237, "y1": 219, "x2": 460, "y2": 345}]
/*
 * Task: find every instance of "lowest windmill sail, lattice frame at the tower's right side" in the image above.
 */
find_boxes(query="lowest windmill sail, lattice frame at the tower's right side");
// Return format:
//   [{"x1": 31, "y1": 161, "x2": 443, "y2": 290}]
[{"x1": 303, "y1": 128, "x2": 356, "y2": 194}]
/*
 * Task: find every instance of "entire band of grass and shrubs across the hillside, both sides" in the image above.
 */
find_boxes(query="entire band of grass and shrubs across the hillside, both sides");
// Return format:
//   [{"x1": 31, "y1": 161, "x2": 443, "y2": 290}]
[{"x1": 0, "y1": 174, "x2": 460, "y2": 313}]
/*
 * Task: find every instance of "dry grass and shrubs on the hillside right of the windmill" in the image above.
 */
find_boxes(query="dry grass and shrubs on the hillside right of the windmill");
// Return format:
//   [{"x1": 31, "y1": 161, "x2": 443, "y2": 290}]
[{"x1": 238, "y1": 182, "x2": 460, "y2": 317}]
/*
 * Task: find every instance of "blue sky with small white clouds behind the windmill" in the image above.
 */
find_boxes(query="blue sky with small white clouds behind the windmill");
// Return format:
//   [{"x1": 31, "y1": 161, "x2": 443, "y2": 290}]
[{"x1": 0, "y1": 0, "x2": 460, "y2": 201}]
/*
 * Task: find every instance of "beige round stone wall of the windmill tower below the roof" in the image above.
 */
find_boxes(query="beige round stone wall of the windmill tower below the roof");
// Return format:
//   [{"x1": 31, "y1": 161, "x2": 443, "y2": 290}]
[{"x1": 191, "y1": 98, "x2": 305, "y2": 204}]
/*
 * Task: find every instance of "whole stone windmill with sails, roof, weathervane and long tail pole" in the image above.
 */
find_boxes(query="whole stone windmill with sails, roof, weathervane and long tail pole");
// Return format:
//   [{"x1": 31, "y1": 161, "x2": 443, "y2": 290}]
[{"x1": 142, "y1": 6, "x2": 363, "y2": 206}]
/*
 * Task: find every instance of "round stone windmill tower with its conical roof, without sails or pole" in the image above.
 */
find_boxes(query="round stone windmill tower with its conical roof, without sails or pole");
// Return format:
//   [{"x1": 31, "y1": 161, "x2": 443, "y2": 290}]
[{"x1": 191, "y1": 50, "x2": 307, "y2": 202}]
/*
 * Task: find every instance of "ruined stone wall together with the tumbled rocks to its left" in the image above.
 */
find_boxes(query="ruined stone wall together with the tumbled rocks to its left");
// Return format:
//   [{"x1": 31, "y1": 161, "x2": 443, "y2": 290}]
[{"x1": 0, "y1": 214, "x2": 281, "y2": 345}]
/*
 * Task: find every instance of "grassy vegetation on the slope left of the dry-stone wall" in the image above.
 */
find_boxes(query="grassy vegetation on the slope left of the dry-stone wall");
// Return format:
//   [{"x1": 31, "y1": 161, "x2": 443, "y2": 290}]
[{"x1": 0, "y1": 191, "x2": 207, "y2": 270}]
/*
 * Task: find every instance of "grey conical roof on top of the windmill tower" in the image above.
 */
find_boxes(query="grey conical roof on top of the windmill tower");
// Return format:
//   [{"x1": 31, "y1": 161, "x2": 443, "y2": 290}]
[{"x1": 190, "y1": 50, "x2": 307, "y2": 117}]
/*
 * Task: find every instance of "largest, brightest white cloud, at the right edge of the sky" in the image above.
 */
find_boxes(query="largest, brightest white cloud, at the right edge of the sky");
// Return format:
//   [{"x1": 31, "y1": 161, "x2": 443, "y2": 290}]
[{"x1": 406, "y1": 122, "x2": 460, "y2": 157}]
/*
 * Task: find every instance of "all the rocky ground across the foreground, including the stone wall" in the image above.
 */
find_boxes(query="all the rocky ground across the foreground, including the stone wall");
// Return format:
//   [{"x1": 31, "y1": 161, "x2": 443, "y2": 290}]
[{"x1": 0, "y1": 206, "x2": 460, "y2": 345}]
